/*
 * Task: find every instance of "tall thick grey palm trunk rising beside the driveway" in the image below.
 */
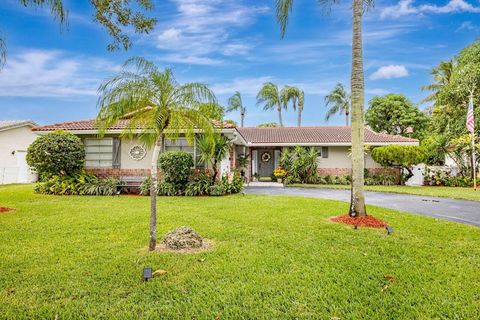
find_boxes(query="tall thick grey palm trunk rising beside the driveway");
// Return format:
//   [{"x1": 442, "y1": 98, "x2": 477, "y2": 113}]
[{"x1": 349, "y1": 0, "x2": 367, "y2": 217}]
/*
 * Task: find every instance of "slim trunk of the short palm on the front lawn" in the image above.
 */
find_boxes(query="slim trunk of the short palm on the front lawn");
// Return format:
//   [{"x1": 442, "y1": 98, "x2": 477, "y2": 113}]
[{"x1": 148, "y1": 135, "x2": 162, "y2": 251}]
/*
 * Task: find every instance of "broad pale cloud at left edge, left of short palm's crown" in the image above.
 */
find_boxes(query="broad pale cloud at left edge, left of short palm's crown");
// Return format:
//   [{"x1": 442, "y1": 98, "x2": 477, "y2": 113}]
[{"x1": 0, "y1": 50, "x2": 120, "y2": 97}]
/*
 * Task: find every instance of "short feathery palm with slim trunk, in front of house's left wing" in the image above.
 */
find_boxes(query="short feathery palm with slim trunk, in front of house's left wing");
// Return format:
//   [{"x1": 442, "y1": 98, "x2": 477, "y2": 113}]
[{"x1": 97, "y1": 58, "x2": 216, "y2": 250}]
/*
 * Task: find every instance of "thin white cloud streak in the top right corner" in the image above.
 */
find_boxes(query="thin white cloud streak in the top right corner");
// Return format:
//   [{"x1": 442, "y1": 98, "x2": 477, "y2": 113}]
[{"x1": 380, "y1": 0, "x2": 480, "y2": 19}]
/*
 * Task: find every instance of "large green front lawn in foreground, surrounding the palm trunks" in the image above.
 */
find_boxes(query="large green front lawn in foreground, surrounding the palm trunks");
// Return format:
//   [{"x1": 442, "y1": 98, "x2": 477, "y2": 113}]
[{"x1": 0, "y1": 186, "x2": 480, "y2": 319}]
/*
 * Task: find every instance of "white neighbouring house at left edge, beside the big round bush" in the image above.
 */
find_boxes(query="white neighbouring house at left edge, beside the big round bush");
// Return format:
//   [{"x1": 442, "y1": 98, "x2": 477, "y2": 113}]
[{"x1": 0, "y1": 120, "x2": 38, "y2": 184}]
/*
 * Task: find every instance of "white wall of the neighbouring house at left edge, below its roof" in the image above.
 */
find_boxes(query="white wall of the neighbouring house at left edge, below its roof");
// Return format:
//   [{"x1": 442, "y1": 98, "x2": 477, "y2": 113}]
[{"x1": 0, "y1": 126, "x2": 38, "y2": 168}]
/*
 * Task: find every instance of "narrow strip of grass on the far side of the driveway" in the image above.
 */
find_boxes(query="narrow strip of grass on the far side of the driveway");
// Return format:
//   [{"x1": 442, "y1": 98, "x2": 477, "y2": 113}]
[{"x1": 287, "y1": 184, "x2": 480, "y2": 201}]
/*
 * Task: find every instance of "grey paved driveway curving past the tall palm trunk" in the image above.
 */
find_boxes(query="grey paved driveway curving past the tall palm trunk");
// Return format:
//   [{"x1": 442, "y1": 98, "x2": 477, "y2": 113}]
[{"x1": 245, "y1": 187, "x2": 480, "y2": 227}]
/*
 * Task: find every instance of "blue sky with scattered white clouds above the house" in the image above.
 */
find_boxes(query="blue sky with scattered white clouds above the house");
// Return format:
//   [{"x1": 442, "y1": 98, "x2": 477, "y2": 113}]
[{"x1": 0, "y1": 0, "x2": 480, "y2": 126}]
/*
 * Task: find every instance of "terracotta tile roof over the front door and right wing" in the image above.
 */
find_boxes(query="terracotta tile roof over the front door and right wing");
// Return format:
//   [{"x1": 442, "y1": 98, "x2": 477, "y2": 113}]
[{"x1": 237, "y1": 126, "x2": 418, "y2": 144}]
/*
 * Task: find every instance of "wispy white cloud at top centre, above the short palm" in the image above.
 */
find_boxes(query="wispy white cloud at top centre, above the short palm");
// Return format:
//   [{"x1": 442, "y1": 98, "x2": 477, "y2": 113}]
[{"x1": 155, "y1": 0, "x2": 269, "y2": 65}]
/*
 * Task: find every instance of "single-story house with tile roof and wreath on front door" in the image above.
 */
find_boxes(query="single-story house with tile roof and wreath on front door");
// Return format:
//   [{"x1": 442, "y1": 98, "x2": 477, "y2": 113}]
[{"x1": 33, "y1": 120, "x2": 418, "y2": 180}]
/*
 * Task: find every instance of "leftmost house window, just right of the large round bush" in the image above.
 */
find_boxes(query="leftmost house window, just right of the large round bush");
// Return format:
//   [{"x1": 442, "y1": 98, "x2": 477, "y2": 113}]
[{"x1": 84, "y1": 138, "x2": 113, "y2": 168}]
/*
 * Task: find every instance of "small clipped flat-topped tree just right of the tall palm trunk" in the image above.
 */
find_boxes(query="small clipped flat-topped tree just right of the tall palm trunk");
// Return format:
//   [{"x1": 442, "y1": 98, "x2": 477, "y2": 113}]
[{"x1": 372, "y1": 145, "x2": 426, "y2": 184}]
